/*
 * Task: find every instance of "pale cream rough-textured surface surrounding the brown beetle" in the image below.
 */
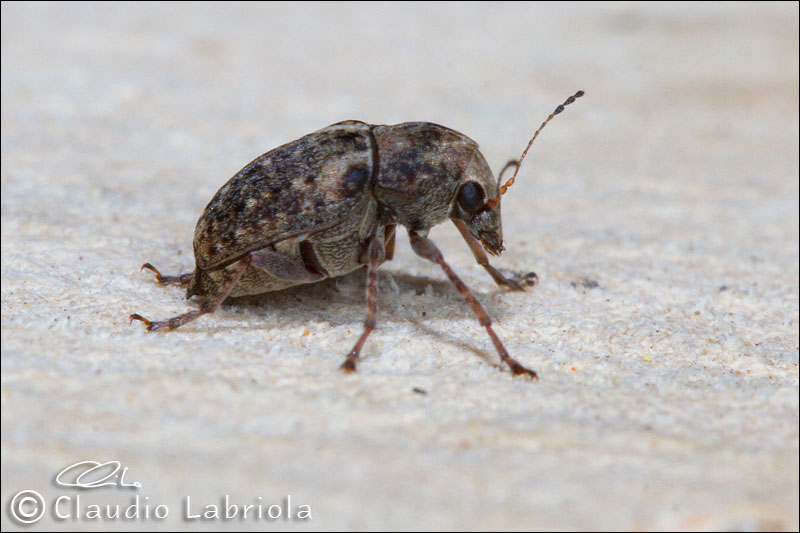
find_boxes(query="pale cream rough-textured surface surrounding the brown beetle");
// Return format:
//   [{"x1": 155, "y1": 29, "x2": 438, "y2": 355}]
[{"x1": 1, "y1": 2, "x2": 798, "y2": 530}]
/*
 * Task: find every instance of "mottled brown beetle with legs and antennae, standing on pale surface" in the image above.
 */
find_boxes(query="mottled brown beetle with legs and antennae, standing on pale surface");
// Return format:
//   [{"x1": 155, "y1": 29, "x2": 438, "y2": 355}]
[{"x1": 130, "y1": 91, "x2": 583, "y2": 378}]
